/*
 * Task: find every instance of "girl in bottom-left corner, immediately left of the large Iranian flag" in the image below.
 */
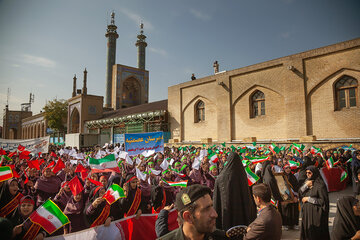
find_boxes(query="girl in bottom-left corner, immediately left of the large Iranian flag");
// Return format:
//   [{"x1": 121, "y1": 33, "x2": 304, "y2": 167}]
[{"x1": 10, "y1": 196, "x2": 46, "y2": 240}]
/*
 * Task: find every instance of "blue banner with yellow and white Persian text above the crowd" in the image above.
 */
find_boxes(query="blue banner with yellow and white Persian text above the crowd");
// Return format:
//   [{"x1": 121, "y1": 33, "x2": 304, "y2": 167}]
[{"x1": 125, "y1": 132, "x2": 164, "y2": 156}]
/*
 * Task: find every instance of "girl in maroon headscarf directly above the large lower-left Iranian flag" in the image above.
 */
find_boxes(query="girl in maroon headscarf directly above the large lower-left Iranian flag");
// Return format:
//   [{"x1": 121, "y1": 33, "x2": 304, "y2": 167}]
[{"x1": 35, "y1": 168, "x2": 61, "y2": 206}]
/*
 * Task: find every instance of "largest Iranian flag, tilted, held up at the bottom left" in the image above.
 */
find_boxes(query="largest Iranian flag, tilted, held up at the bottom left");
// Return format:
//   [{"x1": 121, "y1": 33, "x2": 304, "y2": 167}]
[{"x1": 29, "y1": 199, "x2": 69, "y2": 234}]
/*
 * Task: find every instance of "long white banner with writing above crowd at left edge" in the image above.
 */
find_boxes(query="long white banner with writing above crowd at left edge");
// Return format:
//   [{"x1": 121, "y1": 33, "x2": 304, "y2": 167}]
[{"x1": 0, "y1": 136, "x2": 50, "y2": 153}]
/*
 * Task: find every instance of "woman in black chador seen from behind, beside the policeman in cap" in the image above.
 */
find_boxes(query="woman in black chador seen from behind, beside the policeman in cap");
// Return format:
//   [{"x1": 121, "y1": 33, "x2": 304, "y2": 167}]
[{"x1": 213, "y1": 152, "x2": 256, "y2": 230}]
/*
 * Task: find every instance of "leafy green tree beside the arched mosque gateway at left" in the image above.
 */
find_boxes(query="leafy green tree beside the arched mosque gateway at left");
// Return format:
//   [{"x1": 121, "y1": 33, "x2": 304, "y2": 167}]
[{"x1": 43, "y1": 99, "x2": 68, "y2": 132}]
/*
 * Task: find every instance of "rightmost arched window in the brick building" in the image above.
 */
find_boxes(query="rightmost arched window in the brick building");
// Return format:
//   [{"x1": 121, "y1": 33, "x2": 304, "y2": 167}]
[{"x1": 335, "y1": 75, "x2": 358, "y2": 110}]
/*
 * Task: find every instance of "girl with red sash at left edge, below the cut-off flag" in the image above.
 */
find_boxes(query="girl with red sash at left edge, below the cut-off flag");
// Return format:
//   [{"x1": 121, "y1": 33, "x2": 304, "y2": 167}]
[{"x1": 0, "y1": 178, "x2": 23, "y2": 218}]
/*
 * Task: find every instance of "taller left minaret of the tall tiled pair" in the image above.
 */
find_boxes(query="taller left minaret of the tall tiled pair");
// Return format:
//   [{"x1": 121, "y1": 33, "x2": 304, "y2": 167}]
[{"x1": 105, "y1": 12, "x2": 119, "y2": 107}]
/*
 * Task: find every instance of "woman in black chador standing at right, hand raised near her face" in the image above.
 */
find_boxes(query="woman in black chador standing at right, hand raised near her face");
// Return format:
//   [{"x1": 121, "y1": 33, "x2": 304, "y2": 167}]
[{"x1": 299, "y1": 166, "x2": 330, "y2": 240}]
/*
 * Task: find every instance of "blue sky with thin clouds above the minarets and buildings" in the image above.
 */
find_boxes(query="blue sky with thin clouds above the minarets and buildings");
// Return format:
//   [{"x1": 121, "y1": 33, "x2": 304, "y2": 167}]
[{"x1": 0, "y1": 0, "x2": 360, "y2": 124}]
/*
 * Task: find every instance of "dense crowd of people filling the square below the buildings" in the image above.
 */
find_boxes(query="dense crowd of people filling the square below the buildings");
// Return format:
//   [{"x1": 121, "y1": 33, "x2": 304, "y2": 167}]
[{"x1": 0, "y1": 144, "x2": 360, "y2": 239}]
